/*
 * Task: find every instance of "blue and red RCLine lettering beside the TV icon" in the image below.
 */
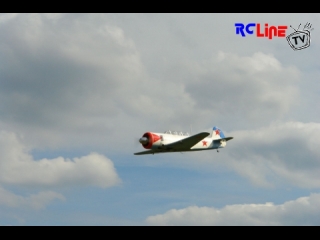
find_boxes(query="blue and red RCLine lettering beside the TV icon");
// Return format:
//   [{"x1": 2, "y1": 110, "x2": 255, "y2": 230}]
[{"x1": 234, "y1": 23, "x2": 288, "y2": 40}]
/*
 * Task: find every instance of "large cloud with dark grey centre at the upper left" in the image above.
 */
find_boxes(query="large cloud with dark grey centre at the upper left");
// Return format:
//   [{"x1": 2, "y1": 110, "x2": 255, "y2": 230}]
[{"x1": 0, "y1": 14, "x2": 146, "y2": 147}]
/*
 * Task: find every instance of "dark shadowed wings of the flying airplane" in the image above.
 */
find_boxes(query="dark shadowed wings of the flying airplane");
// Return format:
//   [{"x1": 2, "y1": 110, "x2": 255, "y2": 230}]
[{"x1": 134, "y1": 132, "x2": 210, "y2": 155}]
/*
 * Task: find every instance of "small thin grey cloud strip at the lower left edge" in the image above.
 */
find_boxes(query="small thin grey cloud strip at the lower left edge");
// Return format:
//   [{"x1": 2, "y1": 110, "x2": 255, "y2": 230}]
[{"x1": 0, "y1": 186, "x2": 65, "y2": 210}]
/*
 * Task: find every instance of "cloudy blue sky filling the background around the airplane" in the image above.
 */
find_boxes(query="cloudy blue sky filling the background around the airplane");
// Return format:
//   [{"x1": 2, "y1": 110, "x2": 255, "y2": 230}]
[{"x1": 0, "y1": 13, "x2": 320, "y2": 226}]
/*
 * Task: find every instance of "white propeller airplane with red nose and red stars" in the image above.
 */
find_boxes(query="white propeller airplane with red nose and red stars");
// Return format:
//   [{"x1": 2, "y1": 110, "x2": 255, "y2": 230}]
[{"x1": 134, "y1": 126, "x2": 233, "y2": 155}]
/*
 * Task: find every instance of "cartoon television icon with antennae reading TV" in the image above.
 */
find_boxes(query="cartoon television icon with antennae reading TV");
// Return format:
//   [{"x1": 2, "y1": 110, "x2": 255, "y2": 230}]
[{"x1": 287, "y1": 23, "x2": 313, "y2": 50}]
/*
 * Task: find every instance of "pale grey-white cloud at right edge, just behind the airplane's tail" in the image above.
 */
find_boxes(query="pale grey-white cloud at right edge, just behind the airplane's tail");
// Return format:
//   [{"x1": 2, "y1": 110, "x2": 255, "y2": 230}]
[{"x1": 225, "y1": 122, "x2": 320, "y2": 188}]
